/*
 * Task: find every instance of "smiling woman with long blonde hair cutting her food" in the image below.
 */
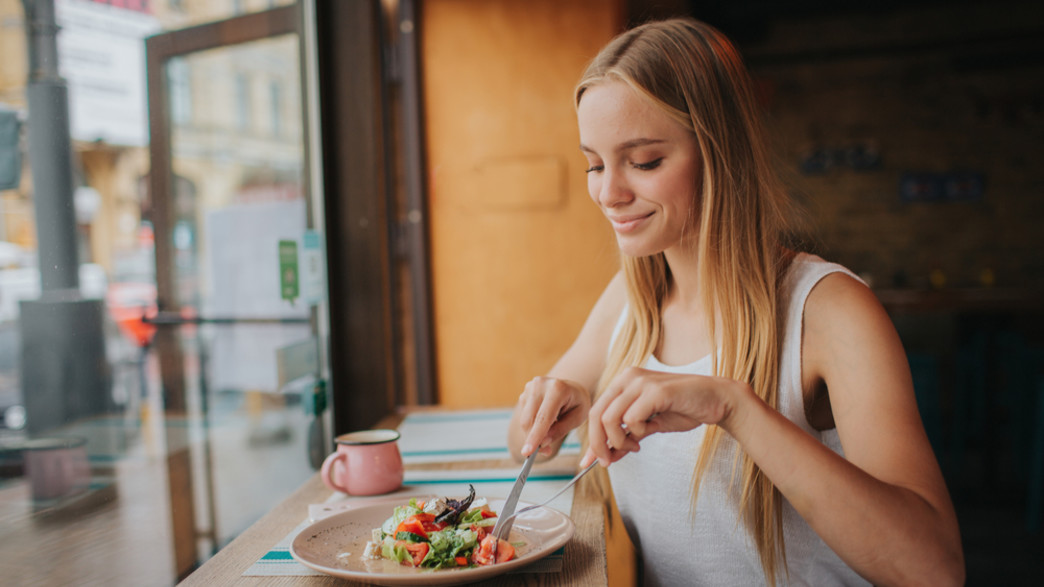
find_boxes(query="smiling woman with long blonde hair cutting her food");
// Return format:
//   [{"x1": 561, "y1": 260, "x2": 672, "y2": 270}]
[{"x1": 508, "y1": 15, "x2": 964, "y2": 585}]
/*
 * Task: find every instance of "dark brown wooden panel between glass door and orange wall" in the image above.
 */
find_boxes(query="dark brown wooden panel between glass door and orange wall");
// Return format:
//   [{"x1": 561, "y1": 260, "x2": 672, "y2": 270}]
[{"x1": 316, "y1": 0, "x2": 397, "y2": 435}]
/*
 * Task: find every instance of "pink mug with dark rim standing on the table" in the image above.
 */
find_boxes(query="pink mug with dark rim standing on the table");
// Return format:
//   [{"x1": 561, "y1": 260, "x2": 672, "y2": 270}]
[{"x1": 319, "y1": 430, "x2": 402, "y2": 495}]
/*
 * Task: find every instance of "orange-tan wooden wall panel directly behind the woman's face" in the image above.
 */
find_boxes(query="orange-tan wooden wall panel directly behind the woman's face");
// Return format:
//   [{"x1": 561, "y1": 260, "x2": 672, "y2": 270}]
[{"x1": 420, "y1": 0, "x2": 623, "y2": 406}]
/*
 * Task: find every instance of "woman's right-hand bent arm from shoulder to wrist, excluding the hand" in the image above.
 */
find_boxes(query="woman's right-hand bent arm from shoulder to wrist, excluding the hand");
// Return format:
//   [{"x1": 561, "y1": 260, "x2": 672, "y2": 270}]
[{"x1": 751, "y1": 274, "x2": 965, "y2": 585}]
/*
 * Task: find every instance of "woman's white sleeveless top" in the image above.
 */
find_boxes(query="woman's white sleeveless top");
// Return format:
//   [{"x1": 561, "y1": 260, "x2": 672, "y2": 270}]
[{"x1": 609, "y1": 254, "x2": 869, "y2": 587}]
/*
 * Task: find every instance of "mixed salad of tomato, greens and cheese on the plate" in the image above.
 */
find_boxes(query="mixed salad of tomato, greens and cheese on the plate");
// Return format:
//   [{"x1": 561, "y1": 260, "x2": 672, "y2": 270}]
[{"x1": 362, "y1": 486, "x2": 521, "y2": 569}]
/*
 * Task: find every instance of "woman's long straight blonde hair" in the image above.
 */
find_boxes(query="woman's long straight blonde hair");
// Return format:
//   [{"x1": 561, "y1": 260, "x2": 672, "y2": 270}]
[{"x1": 575, "y1": 19, "x2": 787, "y2": 584}]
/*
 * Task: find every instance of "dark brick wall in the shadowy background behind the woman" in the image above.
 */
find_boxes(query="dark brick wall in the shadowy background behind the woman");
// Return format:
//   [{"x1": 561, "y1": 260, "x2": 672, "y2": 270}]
[{"x1": 734, "y1": 1, "x2": 1044, "y2": 287}]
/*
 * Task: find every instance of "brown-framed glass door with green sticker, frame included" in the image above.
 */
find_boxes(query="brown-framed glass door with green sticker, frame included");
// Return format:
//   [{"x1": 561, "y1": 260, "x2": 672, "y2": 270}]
[{"x1": 146, "y1": 5, "x2": 327, "y2": 576}]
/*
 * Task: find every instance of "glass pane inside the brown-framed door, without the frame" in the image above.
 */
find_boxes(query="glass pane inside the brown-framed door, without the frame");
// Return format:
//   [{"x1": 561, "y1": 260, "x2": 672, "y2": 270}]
[{"x1": 167, "y1": 31, "x2": 313, "y2": 545}]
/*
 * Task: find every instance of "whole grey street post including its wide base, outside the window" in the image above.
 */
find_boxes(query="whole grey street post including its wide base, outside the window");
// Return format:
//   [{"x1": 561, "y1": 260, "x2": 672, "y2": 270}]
[{"x1": 19, "y1": 0, "x2": 112, "y2": 435}]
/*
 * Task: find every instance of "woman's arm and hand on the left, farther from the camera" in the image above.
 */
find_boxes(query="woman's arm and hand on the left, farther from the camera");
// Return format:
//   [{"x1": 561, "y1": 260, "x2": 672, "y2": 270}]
[{"x1": 507, "y1": 274, "x2": 626, "y2": 459}]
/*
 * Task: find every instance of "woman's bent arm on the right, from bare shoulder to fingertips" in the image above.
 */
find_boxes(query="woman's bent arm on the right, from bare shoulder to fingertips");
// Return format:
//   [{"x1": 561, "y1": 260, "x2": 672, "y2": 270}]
[{"x1": 582, "y1": 274, "x2": 964, "y2": 585}]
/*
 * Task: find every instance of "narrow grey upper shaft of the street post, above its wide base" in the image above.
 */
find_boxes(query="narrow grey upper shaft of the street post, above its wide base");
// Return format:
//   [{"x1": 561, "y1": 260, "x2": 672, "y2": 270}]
[{"x1": 22, "y1": 0, "x2": 79, "y2": 290}]
